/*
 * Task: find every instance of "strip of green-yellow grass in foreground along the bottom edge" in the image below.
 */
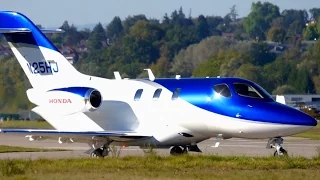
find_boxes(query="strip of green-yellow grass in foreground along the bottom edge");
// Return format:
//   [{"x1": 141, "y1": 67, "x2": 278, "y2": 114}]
[{"x1": 0, "y1": 155, "x2": 320, "y2": 180}]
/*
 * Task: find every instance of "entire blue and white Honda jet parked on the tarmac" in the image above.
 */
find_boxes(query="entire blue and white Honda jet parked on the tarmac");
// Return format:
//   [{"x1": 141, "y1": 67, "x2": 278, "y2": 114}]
[{"x1": 0, "y1": 11, "x2": 317, "y2": 157}]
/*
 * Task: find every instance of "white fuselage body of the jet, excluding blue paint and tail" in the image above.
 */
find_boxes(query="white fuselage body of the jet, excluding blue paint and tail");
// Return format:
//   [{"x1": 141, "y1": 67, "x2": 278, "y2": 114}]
[{"x1": 36, "y1": 76, "x2": 310, "y2": 146}]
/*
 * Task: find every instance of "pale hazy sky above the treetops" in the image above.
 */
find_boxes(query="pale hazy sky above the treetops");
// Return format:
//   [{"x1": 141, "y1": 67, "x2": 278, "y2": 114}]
[{"x1": 0, "y1": 0, "x2": 320, "y2": 28}]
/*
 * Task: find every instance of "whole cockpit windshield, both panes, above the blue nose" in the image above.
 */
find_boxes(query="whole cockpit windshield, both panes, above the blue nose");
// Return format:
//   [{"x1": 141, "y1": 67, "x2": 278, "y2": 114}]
[{"x1": 233, "y1": 83, "x2": 272, "y2": 100}]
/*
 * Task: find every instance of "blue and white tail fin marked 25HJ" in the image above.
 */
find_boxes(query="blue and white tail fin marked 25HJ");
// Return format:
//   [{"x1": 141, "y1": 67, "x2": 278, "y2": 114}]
[{"x1": 0, "y1": 11, "x2": 82, "y2": 88}]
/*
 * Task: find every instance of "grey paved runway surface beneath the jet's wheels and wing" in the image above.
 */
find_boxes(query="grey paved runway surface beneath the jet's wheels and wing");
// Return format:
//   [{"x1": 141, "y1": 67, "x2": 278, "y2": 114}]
[{"x1": 0, "y1": 134, "x2": 320, "y2": 159}]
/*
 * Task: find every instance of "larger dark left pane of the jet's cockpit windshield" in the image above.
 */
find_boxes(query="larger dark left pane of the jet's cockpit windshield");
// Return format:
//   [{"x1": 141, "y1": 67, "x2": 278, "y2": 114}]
[{"x1": 233, "y1": 83, "x2": 263, "y2": 99}]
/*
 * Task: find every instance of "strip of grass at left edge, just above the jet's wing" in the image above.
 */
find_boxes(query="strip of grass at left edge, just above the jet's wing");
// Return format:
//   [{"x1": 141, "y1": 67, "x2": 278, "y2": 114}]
[{"x1": 0, "y1": 120, "x2": 53, "y2": 129}]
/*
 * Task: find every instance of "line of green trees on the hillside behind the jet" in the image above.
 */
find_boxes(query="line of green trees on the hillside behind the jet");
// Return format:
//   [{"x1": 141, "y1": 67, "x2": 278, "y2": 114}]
[{"x1": 0, "y1": 1, "x2": 320, "y2": 111}]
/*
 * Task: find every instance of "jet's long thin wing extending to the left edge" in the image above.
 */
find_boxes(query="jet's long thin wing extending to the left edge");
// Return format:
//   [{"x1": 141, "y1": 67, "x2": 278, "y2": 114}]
[{"x1": 0, "y1": 129, "x2": 151, "y2": 143}]
